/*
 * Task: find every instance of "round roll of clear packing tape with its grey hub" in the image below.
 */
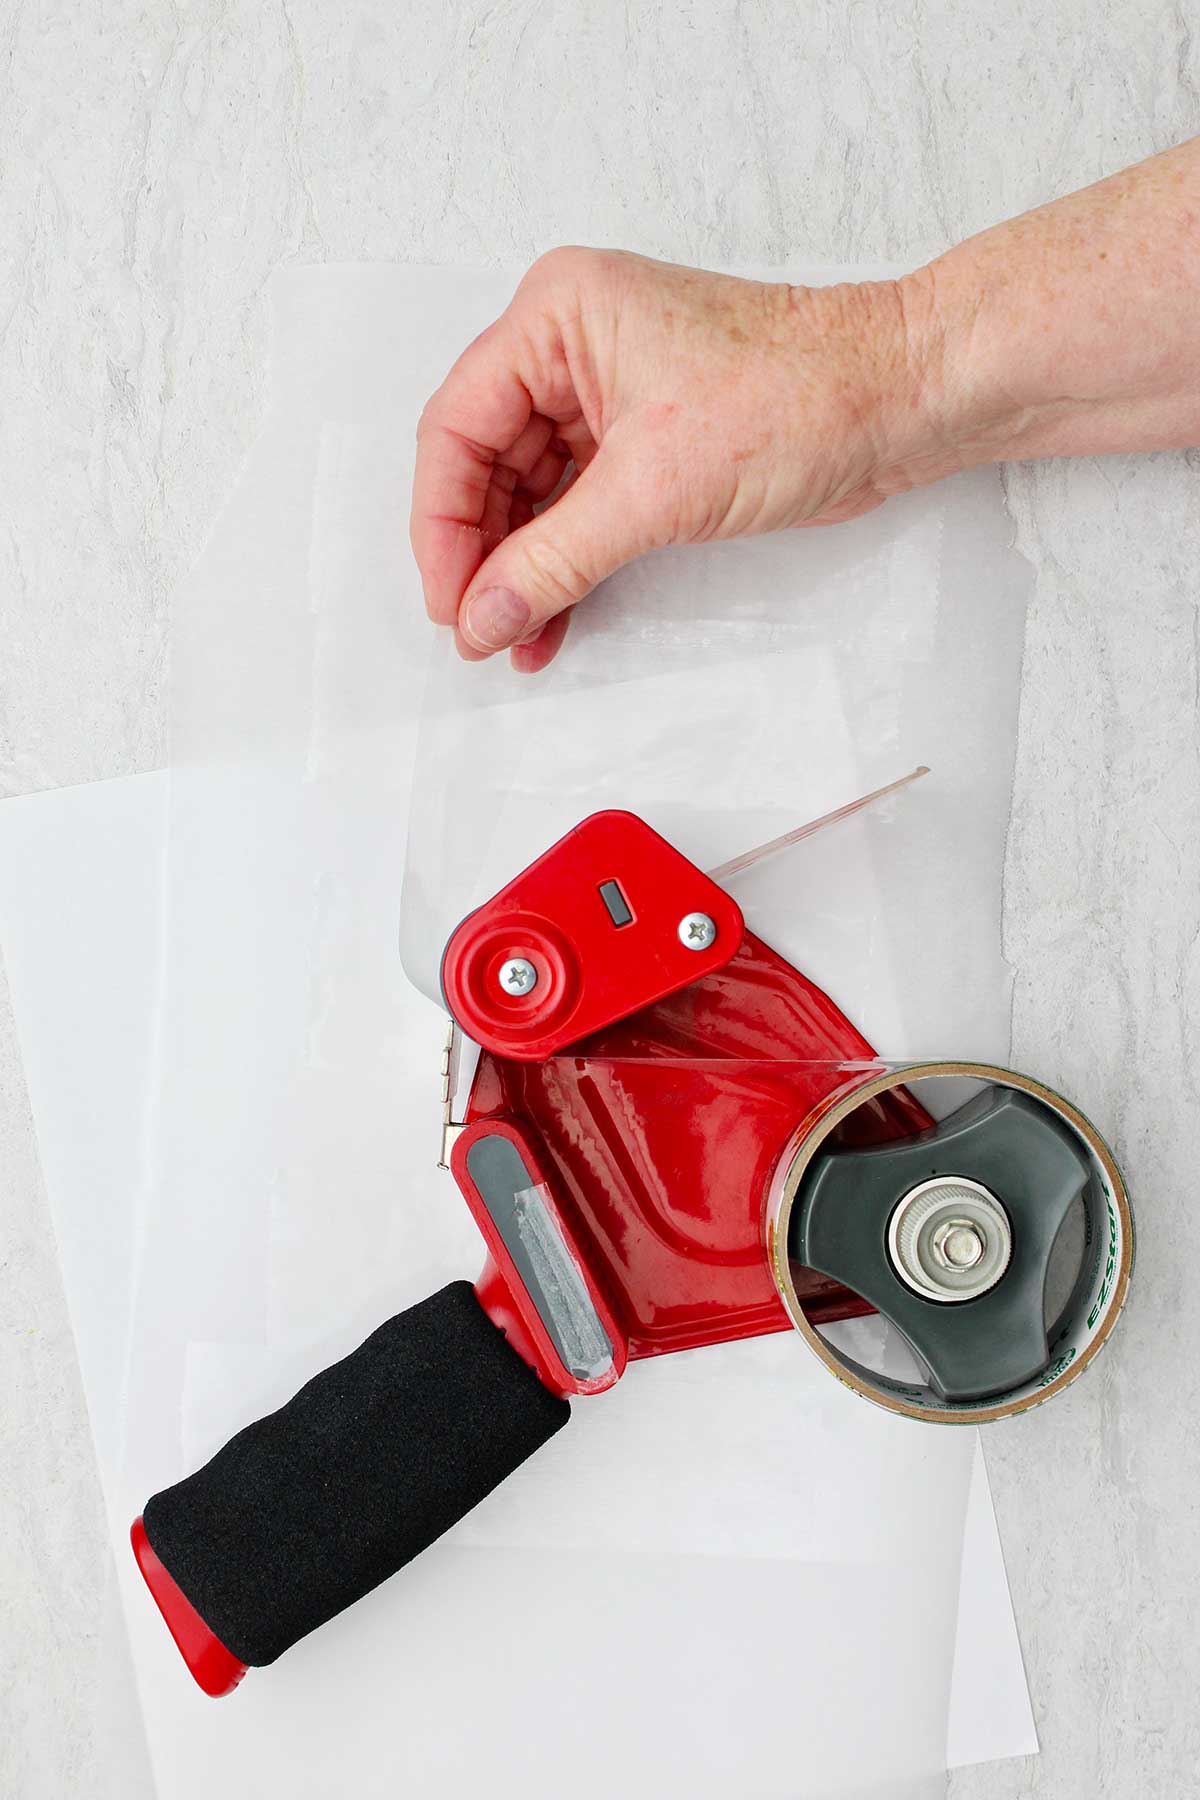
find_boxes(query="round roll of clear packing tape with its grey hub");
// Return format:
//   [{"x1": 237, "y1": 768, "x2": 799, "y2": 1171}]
[{"x1": 766, "y1": 1062, "x2": 1133, "y2": 1424}]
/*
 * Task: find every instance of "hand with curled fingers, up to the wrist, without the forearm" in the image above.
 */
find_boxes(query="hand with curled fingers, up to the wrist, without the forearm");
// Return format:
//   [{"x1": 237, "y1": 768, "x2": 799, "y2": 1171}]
[{"x1": 412, "y1": 250, "x2": 954, "y2": 671}]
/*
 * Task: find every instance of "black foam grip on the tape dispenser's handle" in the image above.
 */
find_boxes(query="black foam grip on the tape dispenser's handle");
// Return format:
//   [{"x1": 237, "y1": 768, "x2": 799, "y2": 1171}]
[{"x1": 142, "y1": 1282, "x2": 570, "y2": 1667}]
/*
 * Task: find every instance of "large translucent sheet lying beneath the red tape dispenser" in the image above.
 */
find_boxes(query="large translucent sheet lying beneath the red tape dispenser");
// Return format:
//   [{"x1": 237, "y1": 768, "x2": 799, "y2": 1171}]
[{"x1": 5, "y1": 268, "x2": 1034, "y2": 1800}]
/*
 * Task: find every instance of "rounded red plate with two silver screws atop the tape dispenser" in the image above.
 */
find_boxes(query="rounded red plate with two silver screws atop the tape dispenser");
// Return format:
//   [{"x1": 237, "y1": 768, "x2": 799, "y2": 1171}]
[{"x1": 443, "y1": 812, "x2": 745, "y2": 1062}]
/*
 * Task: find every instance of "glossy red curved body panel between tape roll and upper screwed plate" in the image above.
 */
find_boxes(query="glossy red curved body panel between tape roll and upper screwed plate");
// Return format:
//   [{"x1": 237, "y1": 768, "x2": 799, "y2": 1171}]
[{"x1": 468, "y1": 932, "x2": 930, "y2": 1360}]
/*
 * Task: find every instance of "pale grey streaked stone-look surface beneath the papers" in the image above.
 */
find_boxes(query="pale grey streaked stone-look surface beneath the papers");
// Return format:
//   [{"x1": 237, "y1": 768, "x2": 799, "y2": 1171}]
[{"x1": 0, "y1": 0, "x2": 1200, "y2": 1800}]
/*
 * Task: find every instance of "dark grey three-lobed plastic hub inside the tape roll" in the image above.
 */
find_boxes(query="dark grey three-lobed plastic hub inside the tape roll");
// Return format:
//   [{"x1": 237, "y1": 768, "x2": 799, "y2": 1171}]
[{"x1": 788, "y1": 1089, "x2": 1088, "y2": 1402}]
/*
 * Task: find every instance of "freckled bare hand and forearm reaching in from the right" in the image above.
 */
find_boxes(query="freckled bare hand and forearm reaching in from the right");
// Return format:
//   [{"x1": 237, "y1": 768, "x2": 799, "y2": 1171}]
[{"x1": 412, "y1": 139, "x2": 1200, "y2": 671}]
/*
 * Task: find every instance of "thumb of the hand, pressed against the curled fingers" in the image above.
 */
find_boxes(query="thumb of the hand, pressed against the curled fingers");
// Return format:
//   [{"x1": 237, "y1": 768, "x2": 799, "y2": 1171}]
[{"x1": 459, "y1": 448, "x2": 651, "y2": 653}]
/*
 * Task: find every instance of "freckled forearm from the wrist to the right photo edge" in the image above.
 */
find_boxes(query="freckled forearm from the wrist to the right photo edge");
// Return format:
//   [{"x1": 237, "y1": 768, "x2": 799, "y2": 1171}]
[{"x1": 900, "y1": 139, "x2": 1200, "y2": 481}]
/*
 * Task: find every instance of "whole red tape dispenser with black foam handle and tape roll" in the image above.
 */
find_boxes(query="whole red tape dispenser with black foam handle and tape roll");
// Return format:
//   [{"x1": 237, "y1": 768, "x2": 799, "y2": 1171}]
[{"x1": 133, "y1": 812, "x2": 1133, "y2": 1694}]
